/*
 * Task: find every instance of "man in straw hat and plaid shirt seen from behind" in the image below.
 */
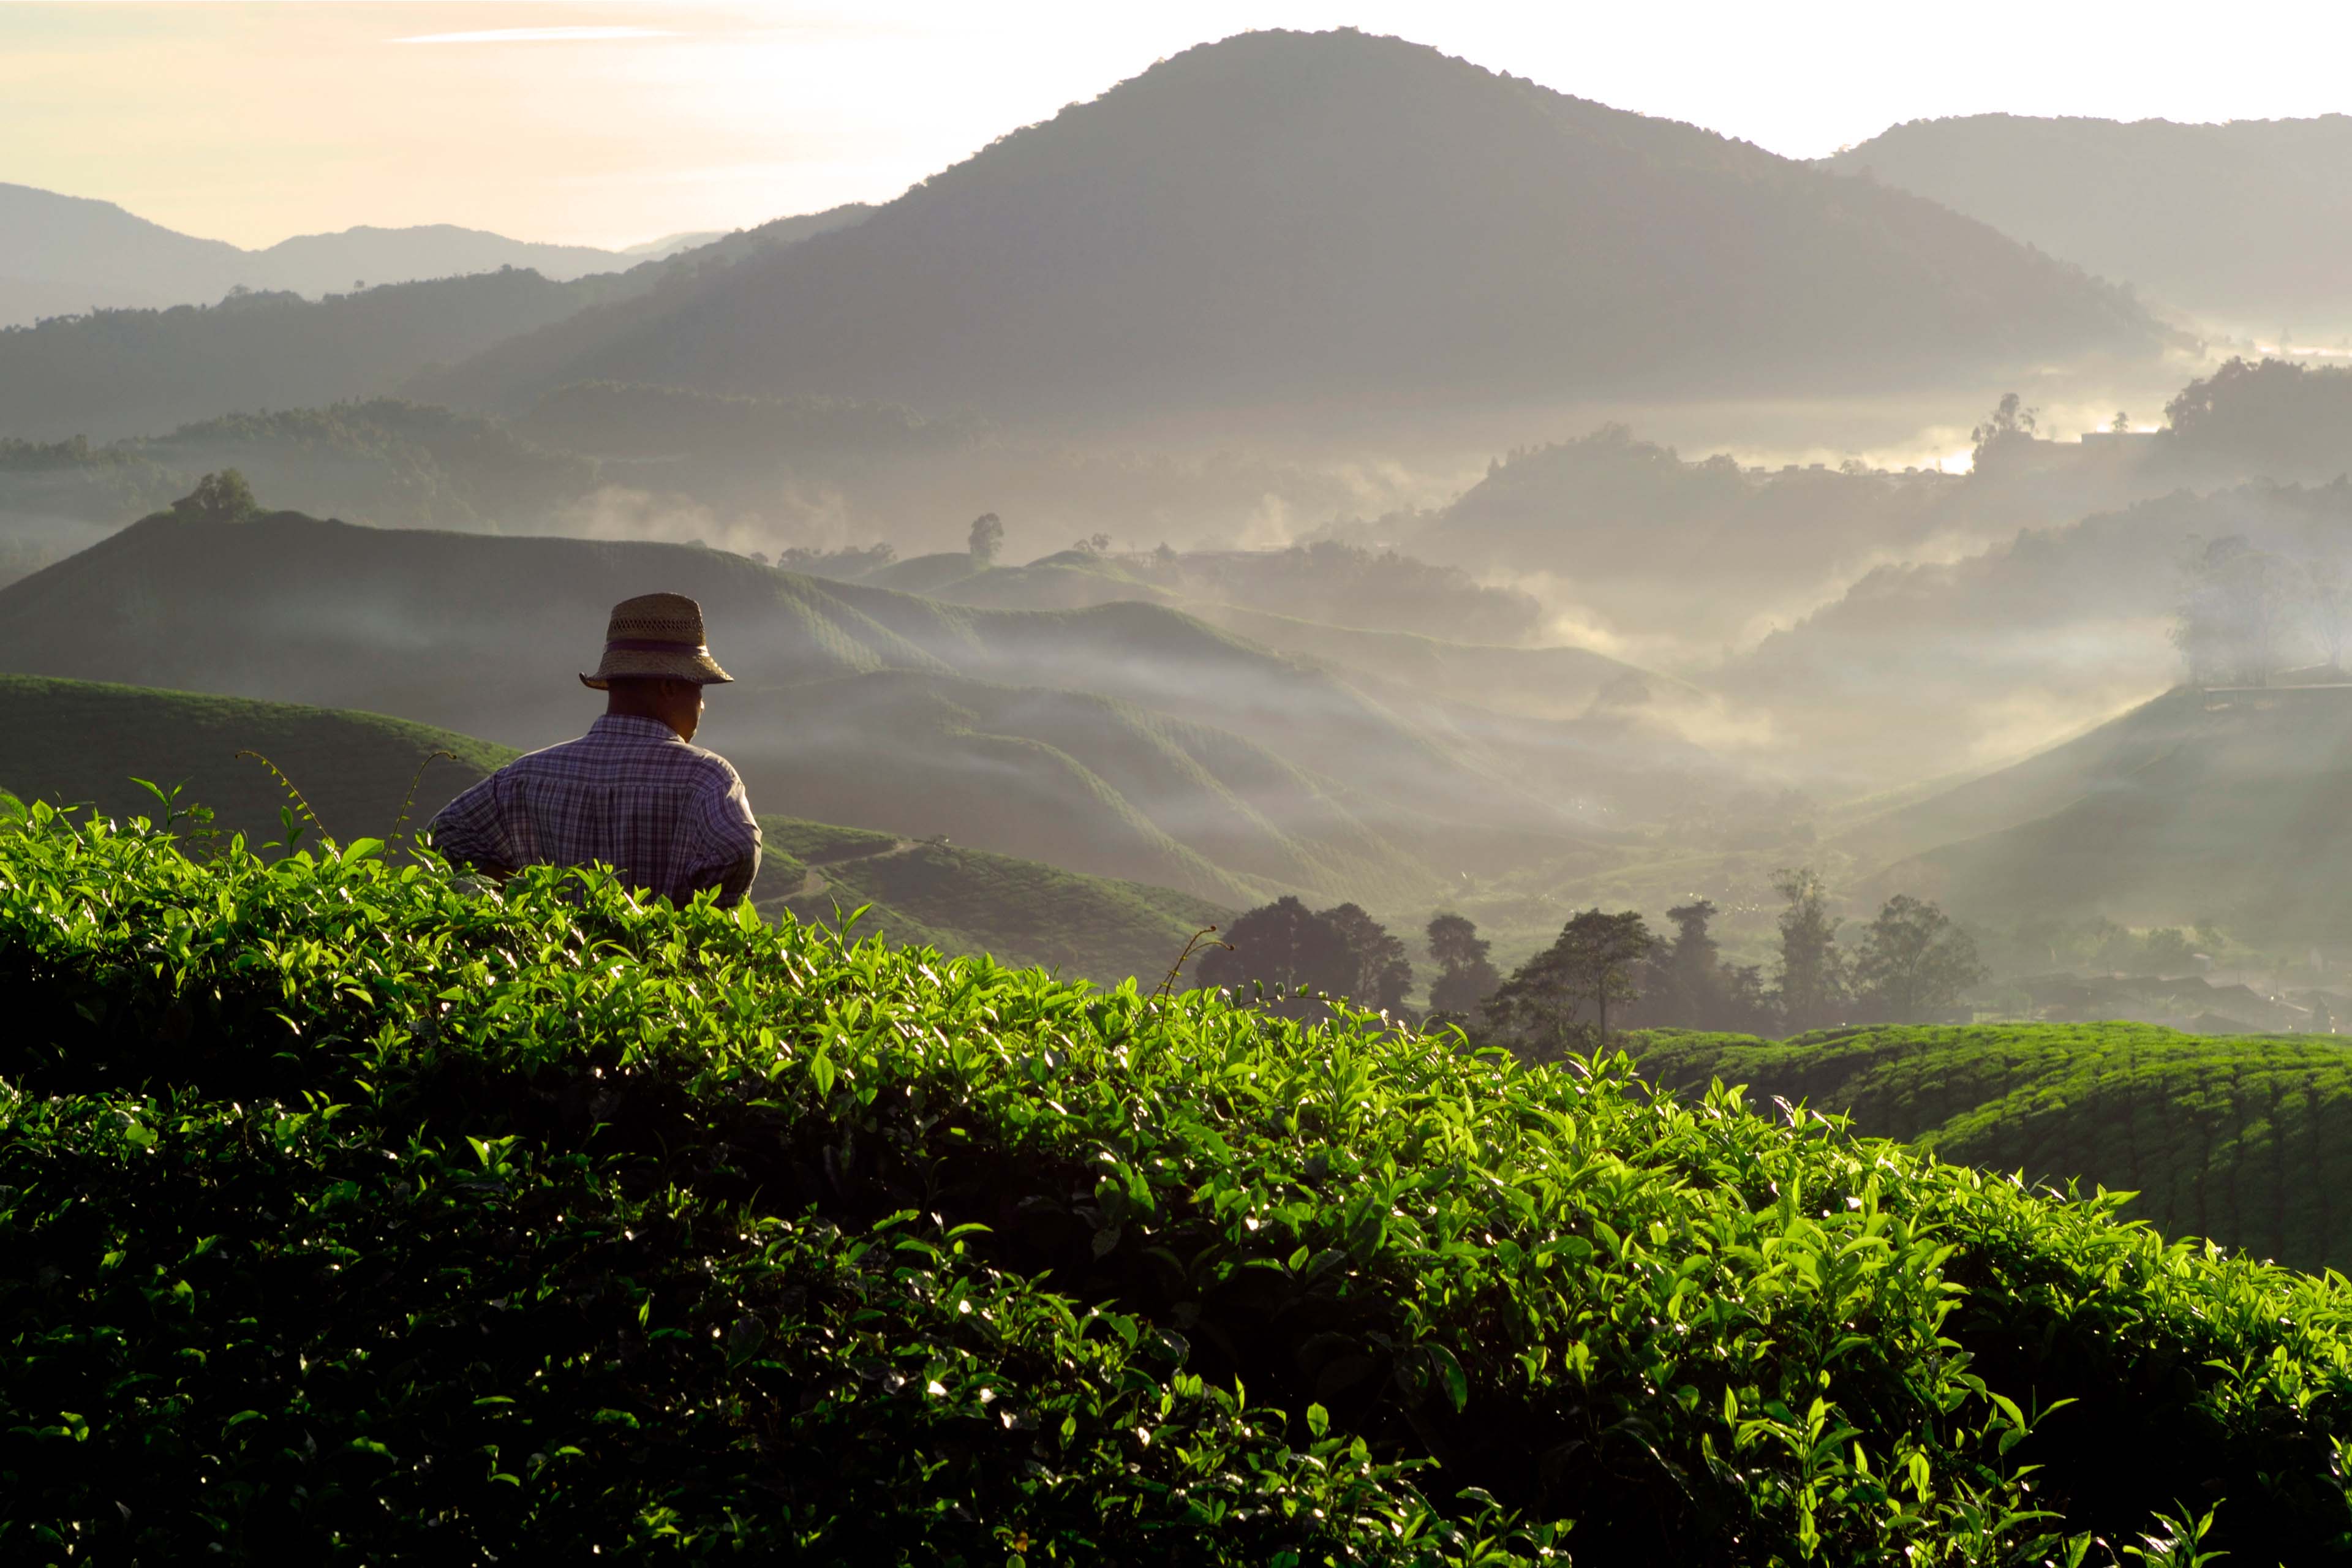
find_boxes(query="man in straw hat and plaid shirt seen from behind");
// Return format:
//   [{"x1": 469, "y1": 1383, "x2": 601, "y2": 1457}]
[{"x1": 431, "y1": 592, "x2": 760, "y2": 905}]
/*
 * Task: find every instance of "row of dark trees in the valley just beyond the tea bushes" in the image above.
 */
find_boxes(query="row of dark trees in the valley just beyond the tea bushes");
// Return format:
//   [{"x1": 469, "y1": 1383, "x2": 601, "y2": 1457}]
[{"x1": 1197, "y1": 867, "x2": 1985, "y2": 1060}]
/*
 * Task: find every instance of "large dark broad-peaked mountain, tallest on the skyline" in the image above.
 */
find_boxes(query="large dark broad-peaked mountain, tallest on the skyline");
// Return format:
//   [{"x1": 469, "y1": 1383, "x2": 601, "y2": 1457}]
[{"x1": 399, "y1": 31, "x2": 2166, "y2": 416}]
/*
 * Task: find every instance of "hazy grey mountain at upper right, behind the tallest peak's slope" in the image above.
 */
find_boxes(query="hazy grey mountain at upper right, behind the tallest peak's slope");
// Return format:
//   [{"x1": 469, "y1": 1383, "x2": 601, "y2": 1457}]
[{"x1": 1828, "y1": 115, "x2": 2352, "y2": 343}]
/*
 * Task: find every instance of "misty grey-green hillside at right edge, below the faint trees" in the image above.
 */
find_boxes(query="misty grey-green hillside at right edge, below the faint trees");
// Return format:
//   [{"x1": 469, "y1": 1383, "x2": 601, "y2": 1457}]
[{"x1": 1879, "y1": 687, "x2": 2352, "y2": 943}]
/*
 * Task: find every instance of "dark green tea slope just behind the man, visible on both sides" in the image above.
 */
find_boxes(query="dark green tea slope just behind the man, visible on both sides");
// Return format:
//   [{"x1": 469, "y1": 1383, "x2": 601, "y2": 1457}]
[{"x1": 0, "y1": 675, "x2": 1251, "y2": 985}]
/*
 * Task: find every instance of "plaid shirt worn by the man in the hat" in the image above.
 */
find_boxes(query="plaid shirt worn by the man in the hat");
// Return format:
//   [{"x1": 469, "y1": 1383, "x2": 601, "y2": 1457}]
[{"x1": 431, "y1": 715, "x2": 760, "y2": 905}]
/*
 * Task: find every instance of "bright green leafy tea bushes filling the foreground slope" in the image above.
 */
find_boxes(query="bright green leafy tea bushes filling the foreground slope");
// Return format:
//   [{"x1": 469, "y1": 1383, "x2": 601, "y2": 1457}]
[{"x1": 0, "y1": 806, "x2": 2352, "y2": 1566}]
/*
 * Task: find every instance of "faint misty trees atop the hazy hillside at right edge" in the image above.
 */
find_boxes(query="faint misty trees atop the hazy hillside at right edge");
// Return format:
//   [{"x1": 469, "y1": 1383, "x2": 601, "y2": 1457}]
[{"x1": 2173, "y1": 533, "x2": 2352, "y2": 687}]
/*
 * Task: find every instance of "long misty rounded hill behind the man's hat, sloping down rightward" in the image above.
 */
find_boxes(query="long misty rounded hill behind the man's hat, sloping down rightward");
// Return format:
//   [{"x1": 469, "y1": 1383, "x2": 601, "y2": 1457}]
[{"x1": 0, "y1": 513, "x2": 1609, "y2": 900}]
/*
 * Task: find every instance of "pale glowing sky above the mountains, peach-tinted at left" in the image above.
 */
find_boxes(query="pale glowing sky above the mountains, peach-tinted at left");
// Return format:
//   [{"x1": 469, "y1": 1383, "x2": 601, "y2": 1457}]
[{"x1": 13, "y1": 0, "x2": 2352, "y2": 244}]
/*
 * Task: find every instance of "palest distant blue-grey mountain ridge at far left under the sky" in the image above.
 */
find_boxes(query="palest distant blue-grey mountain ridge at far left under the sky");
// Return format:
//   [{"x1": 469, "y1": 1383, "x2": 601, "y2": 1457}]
[{"x1": 0, "y1": 183, "x2": 720, "y2": 326}]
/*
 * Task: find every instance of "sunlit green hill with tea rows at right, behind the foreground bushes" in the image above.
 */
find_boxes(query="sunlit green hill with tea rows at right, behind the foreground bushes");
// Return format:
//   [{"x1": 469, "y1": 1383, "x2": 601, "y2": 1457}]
[{"x1": 1632, "y1": 1023, "x2": 2352, "y2": 1270}]
